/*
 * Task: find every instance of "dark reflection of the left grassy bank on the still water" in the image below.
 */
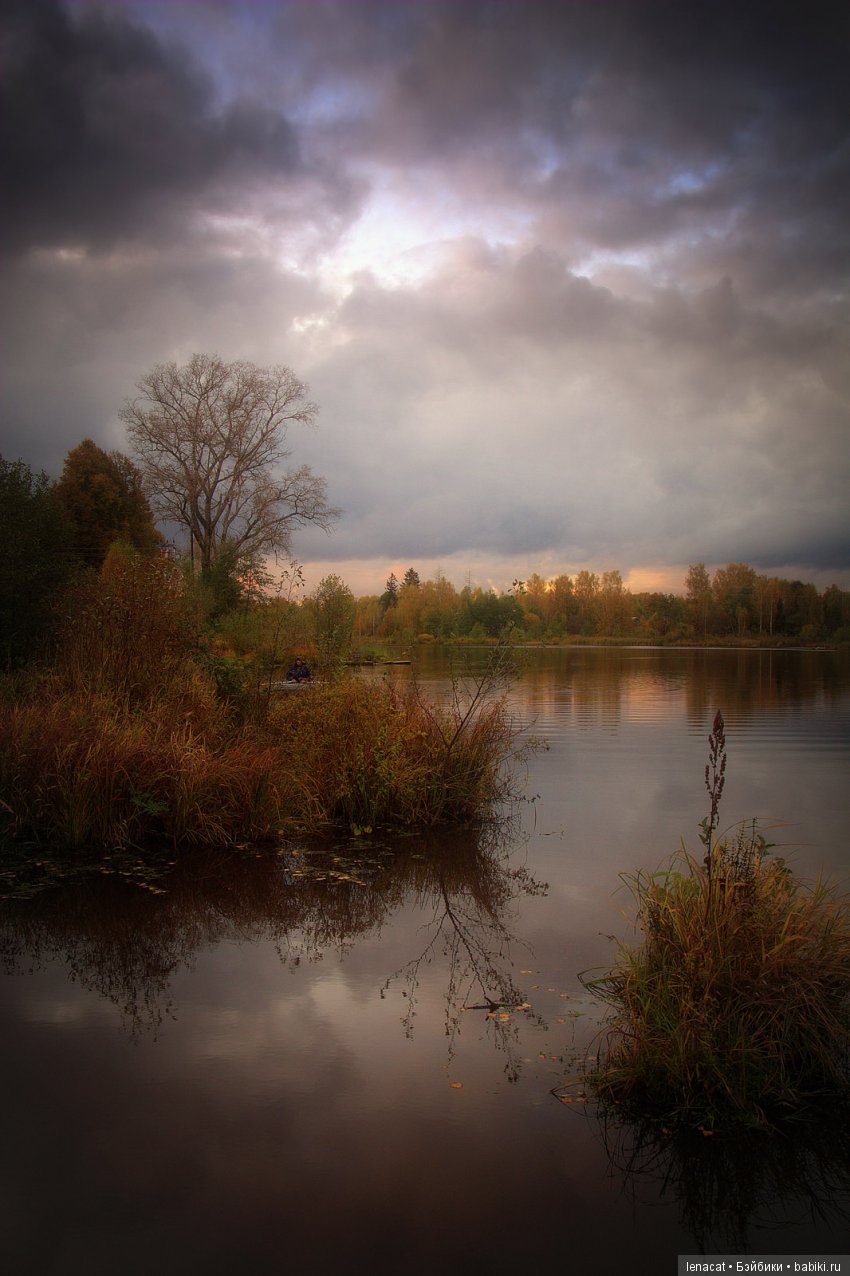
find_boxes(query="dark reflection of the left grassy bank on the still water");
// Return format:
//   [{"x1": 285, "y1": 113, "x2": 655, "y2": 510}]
[{"x1": 0, "y1": 827, "x2": 540, "y2": 1056}]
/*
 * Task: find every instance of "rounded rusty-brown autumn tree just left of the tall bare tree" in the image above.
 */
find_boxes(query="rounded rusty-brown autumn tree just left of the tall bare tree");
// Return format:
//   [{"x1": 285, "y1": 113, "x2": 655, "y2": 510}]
[{"x1": 56, "y1": 439, "x2": 161, "y2": 567}]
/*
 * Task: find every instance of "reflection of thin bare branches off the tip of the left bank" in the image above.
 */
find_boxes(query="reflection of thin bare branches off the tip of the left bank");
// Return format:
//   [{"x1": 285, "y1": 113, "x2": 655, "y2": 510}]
[{"x1": 382, "y1": 831, "x2": 546, "y2": 1081}]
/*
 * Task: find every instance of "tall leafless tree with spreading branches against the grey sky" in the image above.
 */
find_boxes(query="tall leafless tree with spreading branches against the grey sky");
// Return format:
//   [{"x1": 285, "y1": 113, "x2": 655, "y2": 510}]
[{"x1": 121, "y1": 355, "x2": 338, "y2": 569}]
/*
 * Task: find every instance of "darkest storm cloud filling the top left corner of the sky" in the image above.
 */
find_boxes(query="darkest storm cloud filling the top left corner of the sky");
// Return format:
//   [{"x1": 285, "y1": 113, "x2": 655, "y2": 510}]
[{"x1": 0, "y1": 0, "x2": 344, "y2": 249}]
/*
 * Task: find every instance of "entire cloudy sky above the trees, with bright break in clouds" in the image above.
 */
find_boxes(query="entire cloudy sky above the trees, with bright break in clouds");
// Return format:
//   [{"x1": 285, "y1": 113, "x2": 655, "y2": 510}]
[{"x1": 0, "y1": 0, "x2": 850, "y2": 595}]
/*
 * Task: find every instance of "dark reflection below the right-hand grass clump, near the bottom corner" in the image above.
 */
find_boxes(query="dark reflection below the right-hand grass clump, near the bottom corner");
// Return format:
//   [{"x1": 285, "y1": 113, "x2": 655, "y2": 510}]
[{"x1": 589, "y1": 1111, "x2": 850, "y2": 1253}]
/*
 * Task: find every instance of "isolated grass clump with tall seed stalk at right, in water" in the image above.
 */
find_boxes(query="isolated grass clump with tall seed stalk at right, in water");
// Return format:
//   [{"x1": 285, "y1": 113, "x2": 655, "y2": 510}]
[{"x1": 585, "y1": 716, "x2": 850, "y2": 1132}]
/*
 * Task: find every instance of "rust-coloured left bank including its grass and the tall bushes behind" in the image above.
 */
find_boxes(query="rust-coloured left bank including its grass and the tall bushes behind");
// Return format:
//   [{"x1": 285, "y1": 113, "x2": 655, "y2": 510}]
[{"x1": 0, "y1": 546, "x2": 530, "y2": 851}]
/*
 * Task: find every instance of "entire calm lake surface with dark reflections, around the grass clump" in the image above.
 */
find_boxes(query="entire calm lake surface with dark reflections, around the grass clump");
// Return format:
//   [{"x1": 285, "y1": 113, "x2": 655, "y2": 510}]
[{"x1": 0, "y1": 649, "x2": 850, "y2": 1276}]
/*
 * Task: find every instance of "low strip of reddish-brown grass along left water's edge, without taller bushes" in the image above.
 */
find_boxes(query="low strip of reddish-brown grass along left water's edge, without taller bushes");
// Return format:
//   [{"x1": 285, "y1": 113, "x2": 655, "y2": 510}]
[{"x1": 0, "y1": 670, "x2": 518, "y2": 849}]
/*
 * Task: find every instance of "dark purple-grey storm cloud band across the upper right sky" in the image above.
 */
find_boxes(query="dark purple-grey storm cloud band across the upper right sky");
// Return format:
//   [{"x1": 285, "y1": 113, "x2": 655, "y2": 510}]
[{"x1": 280, "y1": 0, "x2": 850, "y2": 291}]
